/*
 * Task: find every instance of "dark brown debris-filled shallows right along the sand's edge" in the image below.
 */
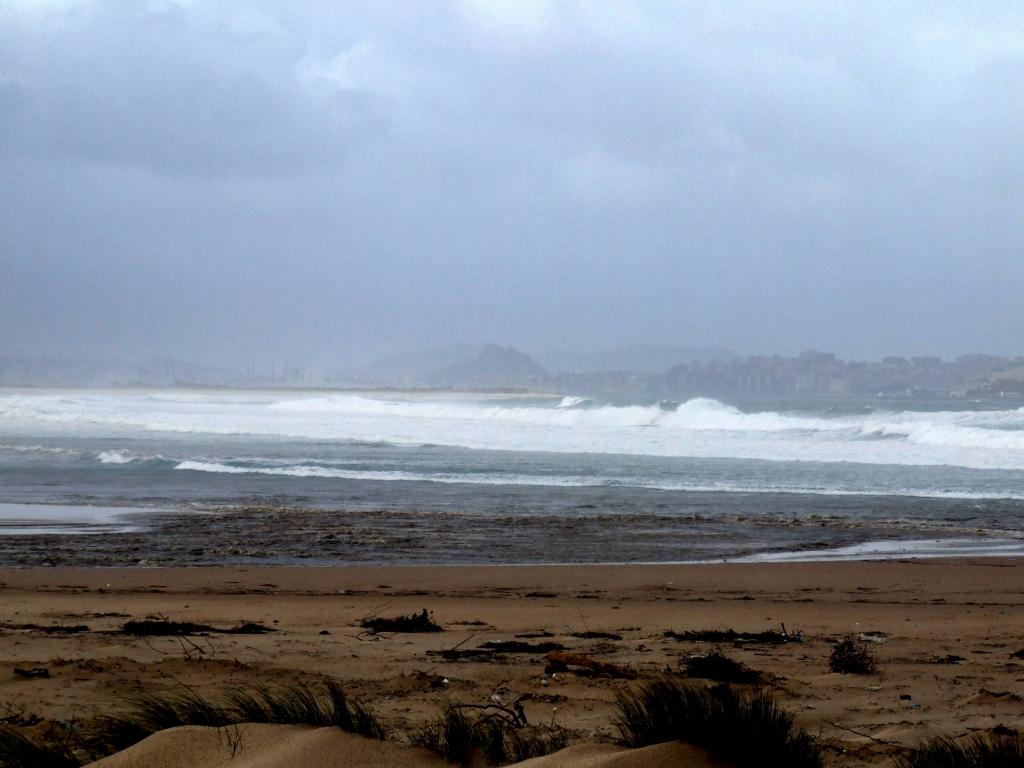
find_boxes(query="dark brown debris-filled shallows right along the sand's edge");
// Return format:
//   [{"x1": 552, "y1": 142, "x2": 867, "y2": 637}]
[{"x1": 0, "y1": 503, "x2": 1024, "y2": 568}]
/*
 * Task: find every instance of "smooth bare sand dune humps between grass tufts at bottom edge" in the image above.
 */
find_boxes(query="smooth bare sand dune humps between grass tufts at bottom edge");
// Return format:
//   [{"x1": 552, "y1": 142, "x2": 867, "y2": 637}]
[{"x1": 92, "y1": 725, "x2": 712, "y2": 768}]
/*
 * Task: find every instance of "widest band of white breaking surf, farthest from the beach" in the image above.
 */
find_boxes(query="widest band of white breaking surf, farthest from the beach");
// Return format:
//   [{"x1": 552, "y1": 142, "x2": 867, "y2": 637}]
[{"x1": 6, "y1": 391, "x2": 1024, "y2": 471}]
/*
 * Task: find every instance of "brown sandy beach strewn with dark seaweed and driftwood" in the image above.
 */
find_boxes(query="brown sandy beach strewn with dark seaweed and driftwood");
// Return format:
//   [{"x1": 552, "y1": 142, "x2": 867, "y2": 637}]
[{"x1": 0, "y1": 558, "x2": 1024, "y2": 766}]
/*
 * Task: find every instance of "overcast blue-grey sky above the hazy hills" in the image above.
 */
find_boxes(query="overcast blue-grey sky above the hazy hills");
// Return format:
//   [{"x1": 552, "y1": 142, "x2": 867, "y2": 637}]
[{"x1": 0, "y1": 0, "x2": 1024, "y2": 366}]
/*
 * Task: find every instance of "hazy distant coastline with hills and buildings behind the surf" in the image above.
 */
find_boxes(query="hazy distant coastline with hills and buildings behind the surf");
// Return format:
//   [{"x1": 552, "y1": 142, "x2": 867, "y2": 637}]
[{"x1": 0, "y1": 344, "x2": 1024, "y2": 402}]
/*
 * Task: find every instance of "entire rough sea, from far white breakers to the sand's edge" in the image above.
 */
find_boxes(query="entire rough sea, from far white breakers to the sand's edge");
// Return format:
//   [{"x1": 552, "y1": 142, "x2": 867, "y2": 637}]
[{"x1": 0, "y1": 389, "x2": 1024, "y2": 564}]
